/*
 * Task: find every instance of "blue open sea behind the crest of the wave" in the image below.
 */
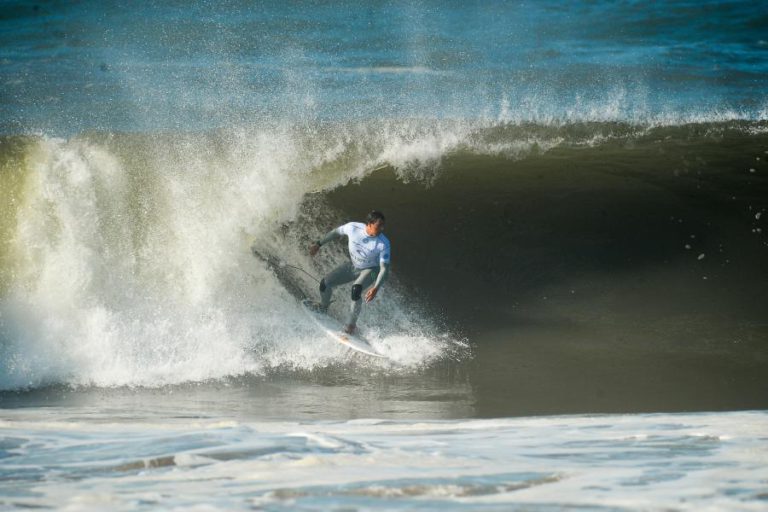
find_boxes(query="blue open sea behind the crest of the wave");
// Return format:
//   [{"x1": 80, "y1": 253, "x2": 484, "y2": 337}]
[{"x1": 0, "y1": 1, "x2": 768, "y2": 135}]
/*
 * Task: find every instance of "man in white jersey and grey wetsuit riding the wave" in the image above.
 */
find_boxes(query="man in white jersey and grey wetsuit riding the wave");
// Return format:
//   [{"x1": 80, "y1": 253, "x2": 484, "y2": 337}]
[{"x1": 309, "y1": 210, "x2": 390, "y2": 334}]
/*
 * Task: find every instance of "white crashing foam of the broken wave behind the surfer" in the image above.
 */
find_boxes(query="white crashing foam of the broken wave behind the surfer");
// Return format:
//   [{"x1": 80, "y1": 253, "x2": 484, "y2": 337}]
[{"x1": 0, "y1": 123, "x2": 484, "y2": 389}]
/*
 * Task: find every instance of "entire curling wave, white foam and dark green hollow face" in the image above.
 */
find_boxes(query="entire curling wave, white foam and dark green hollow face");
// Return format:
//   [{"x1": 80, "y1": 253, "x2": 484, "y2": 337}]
[{"x1": 0, "y1": 121, "x2": 768, "y2": 400}]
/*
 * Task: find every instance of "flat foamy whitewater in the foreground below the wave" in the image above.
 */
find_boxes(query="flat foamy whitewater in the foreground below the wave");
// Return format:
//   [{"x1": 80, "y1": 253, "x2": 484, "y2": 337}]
[{"x1": 0, "y1": 409, "x2": 768, "y2": 511}]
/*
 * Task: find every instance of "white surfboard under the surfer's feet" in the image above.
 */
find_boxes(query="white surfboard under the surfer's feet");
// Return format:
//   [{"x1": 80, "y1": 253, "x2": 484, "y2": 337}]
[{"x1": 251, "y1": 247, "x2": 387, "y2": 358}]
